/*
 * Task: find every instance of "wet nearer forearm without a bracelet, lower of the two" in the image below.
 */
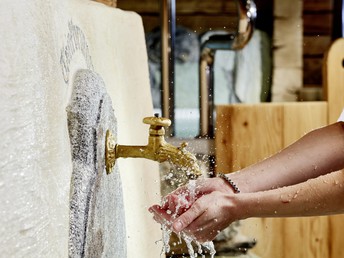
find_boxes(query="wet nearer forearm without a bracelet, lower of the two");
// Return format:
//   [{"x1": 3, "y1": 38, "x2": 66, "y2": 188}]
[{"x1": 235, "y1": 171, "x2": 344, "y2": 219}]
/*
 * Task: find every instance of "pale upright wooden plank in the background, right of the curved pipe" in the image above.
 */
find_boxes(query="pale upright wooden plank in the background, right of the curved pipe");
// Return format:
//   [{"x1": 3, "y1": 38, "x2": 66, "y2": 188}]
[{"x1": 271, "y1": 0, "x2": 303, "y2": 101}]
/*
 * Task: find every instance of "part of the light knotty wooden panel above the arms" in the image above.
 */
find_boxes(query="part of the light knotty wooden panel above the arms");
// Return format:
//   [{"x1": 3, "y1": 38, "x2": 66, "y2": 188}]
[{"x1": 215, "y1": 101, "x2": 327, "y2": 172}]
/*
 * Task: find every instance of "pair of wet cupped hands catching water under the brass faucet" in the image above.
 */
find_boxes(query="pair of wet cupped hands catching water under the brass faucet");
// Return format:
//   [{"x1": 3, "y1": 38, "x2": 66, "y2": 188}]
[{"x1": 149, "y1": 178, "x2": 239, "y2": 241}]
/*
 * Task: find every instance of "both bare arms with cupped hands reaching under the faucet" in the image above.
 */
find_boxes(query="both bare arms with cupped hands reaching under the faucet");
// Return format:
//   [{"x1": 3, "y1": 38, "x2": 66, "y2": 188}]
[{"x1": 151, "y1": 122, "x2": 344, "y2": 241}]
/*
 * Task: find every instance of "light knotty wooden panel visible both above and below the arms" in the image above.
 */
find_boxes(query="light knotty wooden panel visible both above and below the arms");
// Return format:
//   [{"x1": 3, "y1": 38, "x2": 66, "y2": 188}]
[{"x1": 215, "y1": 102, "x2": 330, "y2": 258}]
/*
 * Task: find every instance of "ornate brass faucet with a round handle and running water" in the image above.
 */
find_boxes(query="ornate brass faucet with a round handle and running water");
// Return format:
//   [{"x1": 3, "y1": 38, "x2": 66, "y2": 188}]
[{"x1": 105, "y1": 114, "x2": 201, "y2": 178}]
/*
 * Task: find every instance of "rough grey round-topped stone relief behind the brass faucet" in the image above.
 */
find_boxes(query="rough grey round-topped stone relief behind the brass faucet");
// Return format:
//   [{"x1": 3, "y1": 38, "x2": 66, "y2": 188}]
[{"x1": 67, "y1": 70, "x2": 127, "y2": 258}]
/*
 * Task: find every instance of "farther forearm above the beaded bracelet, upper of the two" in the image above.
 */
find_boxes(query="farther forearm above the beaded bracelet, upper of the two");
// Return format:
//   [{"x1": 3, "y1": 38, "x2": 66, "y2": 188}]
[{"x1": 230, "y1": 123, "x2": 344, "y2": 192}]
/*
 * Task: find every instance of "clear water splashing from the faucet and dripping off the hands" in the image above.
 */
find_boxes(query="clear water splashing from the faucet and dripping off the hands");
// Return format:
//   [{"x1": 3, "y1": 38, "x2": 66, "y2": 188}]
[{"x1": 162, "y1": 180, "x2": 216, "y2": 258}]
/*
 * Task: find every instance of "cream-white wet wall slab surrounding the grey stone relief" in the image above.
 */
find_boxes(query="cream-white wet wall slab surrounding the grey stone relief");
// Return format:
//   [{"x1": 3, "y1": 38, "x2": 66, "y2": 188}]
[{"x1": 0, "y1": 0, "x2": 161, "y2": 258}]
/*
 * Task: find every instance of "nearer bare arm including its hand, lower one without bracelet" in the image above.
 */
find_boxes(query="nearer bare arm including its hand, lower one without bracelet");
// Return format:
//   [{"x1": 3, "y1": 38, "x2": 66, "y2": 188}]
[{"x1": 169, "y1": 171, "x2": 344, "y2": 242}]
